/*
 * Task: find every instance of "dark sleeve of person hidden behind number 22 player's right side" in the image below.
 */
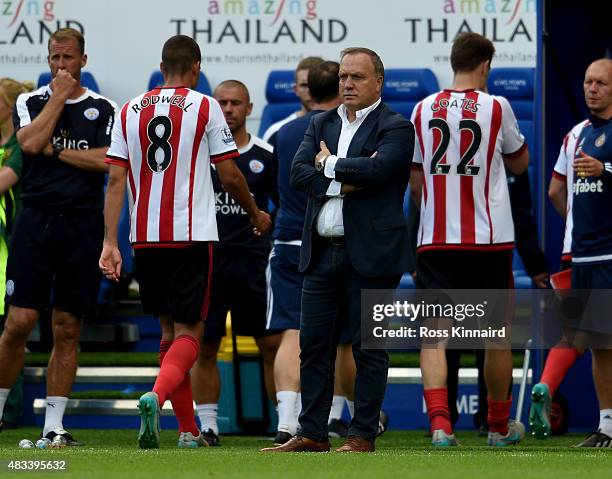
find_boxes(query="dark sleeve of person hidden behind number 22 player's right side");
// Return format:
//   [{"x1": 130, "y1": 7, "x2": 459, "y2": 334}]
[{"x1": 506, "y1": 168, "x2": 548, "y2": 277}]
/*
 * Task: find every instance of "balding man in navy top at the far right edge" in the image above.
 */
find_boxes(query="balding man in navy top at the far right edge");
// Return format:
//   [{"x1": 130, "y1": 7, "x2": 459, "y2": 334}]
[{"x1": 530, "y1": 59, "x2": 612, "y2": 447}]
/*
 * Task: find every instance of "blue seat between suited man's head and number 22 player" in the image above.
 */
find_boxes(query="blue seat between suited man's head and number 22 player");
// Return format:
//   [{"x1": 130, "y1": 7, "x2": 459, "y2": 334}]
[{"x1": 382, "y1": 68, "x2": 440, "y2": 119}]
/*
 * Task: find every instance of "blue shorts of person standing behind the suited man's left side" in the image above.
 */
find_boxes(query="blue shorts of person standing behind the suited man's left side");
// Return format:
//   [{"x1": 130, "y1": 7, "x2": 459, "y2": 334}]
[{"x1": 266, "y1": 243, "x2": 352, "y2": 344}]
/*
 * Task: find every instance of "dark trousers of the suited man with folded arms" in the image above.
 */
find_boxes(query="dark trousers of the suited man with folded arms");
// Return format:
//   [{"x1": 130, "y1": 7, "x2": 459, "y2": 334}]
[{"x1": 299, "y1": 239, "x2": 400, "y2": 442}]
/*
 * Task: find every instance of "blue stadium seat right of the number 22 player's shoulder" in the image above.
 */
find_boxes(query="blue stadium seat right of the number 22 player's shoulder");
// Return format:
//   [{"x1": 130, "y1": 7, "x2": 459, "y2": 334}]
[{"x1": 487, "y1": 68, "x2": 539, "y2": 288}]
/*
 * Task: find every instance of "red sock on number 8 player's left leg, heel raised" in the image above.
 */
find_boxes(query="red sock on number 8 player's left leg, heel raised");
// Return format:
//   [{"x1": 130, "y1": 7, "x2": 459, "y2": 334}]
[{"x1": 153, "y1": 335, "x2": 200, "y2": 408}]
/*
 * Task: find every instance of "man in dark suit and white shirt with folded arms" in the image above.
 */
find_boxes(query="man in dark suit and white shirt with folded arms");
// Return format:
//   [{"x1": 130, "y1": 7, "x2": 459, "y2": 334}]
[{"x1": 267, "y1": 48, "x2": 414, "y2": 452}]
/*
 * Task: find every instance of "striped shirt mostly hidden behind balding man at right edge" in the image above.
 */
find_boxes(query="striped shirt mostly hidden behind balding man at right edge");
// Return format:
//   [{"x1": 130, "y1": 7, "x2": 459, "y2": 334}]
[{"x1": 553, "y1": 120, "x2": 589, "y2": 261}]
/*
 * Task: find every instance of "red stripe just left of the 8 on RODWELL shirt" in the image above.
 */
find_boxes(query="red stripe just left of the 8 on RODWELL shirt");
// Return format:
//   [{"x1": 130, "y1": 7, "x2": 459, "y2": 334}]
[{"x1": 136, "y1": 92, "x2": 155, "y2": 242}]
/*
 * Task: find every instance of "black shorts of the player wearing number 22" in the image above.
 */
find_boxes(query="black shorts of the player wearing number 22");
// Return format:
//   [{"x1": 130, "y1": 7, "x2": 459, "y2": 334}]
[{"x1": 416, "y1": 250, "x2": 514, "y2": 289}]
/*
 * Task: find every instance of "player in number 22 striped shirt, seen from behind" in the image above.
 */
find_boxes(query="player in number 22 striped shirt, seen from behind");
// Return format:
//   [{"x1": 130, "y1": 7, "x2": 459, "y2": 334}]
[{"x1": 410, "y1": 33, "x2": 529, "y2": 446}]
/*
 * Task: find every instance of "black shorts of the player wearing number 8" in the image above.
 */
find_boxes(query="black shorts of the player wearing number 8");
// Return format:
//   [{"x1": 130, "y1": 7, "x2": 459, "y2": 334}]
[{"x1": 134, "y1": 243, "x2": 213, "y2": 324}]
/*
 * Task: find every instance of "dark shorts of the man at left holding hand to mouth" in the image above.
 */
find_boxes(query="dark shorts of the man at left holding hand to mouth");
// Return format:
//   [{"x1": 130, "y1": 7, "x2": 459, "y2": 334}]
[{"x1": 6, "y1": 206, "x2": 104, "y2": 316}]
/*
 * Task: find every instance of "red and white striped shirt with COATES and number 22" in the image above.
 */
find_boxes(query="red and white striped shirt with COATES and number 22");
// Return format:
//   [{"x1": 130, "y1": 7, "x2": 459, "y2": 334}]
[{"x1": 411, "y1": 90, "x2": 526, "y2": 251}]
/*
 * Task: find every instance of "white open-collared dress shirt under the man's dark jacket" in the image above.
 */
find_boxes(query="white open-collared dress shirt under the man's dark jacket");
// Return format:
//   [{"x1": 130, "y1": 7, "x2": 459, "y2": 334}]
[{"x1": 317, "y1": 98, "x2": 381, "y2": 237}]
